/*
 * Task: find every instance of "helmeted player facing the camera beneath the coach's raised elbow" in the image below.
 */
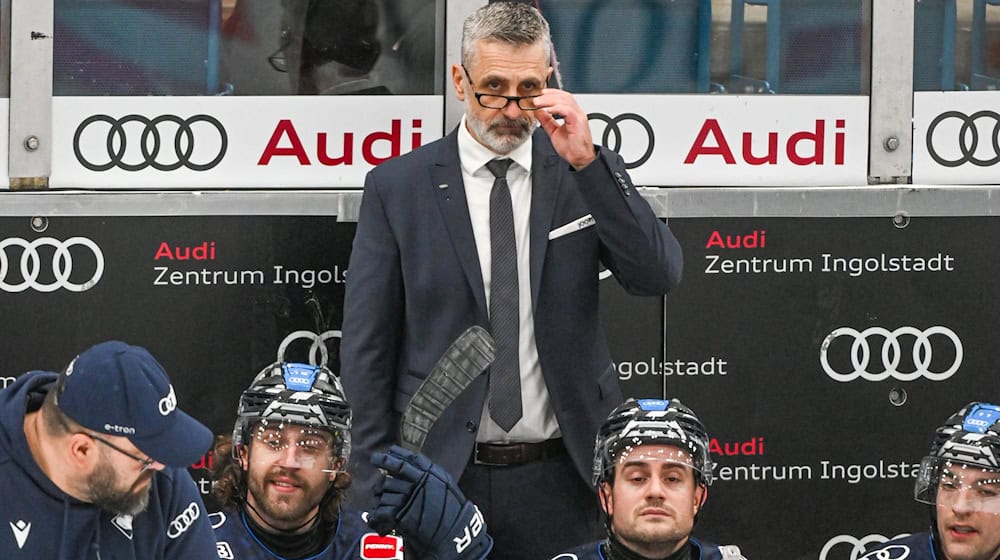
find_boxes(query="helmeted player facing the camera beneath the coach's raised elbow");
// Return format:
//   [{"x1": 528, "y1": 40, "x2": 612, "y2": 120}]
[{"x1": 552, "y1": 399, "x2": 745, "y2": 560}]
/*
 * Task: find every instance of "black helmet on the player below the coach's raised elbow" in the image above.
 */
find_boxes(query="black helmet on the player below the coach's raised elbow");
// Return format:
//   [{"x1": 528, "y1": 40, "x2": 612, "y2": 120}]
[{"x1": 592, "y1": 399, "x2": 714, "y2": 487}]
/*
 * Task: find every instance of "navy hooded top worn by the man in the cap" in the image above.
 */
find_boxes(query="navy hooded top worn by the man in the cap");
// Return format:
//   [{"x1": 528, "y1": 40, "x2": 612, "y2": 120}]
[{"x1": 0, "y1": 371, "x2": 215, "y2": 560}]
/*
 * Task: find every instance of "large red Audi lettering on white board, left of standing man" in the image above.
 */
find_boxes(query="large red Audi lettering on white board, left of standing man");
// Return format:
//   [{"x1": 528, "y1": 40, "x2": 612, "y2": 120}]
[{"x1": 257, "y1": 119, "x2": 421, "y2": 166}]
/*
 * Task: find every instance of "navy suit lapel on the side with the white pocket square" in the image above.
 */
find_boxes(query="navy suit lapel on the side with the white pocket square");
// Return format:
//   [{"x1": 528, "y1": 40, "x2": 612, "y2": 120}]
[{"x1": 529, "y1": 128, "x2": 565, "y2": 308}]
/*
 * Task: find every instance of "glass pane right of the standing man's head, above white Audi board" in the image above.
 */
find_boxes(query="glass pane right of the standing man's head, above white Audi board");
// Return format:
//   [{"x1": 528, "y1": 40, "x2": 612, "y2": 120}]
[{"x1": 537, "y1": 0, "x2": 871, "y2": 95}]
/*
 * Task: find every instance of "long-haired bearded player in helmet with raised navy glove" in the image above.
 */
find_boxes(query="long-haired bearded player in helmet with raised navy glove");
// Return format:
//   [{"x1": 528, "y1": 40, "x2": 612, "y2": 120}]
[{"x1": 212, "y1": 363, "x2": 493, "y2": 560}]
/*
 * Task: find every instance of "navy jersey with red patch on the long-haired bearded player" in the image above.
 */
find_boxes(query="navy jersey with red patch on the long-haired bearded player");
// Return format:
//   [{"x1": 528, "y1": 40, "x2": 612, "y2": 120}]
[{"x1": 210, "y1": 511, "x2": 403, "y2": 560}]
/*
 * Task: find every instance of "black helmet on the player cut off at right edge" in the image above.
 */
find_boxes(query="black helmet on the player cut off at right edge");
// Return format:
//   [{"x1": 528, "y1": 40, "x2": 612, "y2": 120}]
[{"x1": 913, "y1": 402, "x2": 1000, "y2": 513}]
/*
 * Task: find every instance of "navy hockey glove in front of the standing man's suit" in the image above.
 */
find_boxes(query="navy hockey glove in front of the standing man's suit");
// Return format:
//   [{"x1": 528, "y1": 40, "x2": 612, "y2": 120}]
[{"x1": 368, "y1": 445, "x2": 493, "y2": 560}]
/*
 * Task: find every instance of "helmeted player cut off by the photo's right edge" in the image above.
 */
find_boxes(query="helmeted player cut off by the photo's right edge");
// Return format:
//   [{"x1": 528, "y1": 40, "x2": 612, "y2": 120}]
[{"x1": 860, "y1": 402, "x2": 1000, "y2": 560}]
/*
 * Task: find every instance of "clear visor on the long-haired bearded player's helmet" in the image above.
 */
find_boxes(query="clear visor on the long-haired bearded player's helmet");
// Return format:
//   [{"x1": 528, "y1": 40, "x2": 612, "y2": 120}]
[{"x1": 248, "y1": 420, "x2": 347, "y2": 472}]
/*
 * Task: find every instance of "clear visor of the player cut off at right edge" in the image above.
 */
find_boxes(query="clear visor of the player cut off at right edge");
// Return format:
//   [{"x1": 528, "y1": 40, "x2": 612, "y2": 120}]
[{"x1": 913, "y1": 457, "x2": 1000, "y2": 515}]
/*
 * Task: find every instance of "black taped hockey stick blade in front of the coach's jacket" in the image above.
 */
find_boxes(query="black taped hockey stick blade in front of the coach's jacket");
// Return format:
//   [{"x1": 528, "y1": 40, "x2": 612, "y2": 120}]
[{"x1": 400, "y1": 325, "x2": 496, "y2": 452}]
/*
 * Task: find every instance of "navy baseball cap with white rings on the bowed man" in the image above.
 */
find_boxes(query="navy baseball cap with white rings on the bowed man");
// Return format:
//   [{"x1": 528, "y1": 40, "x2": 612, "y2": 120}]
[{"x1": 56, "y1": 340, "x2": 212, "y2": 467}]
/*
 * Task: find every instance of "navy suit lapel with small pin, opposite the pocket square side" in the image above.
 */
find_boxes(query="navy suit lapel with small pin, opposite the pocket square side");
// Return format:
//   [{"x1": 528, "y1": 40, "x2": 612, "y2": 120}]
[{"x1": 430, "y1": 129, "x2": 488, "y2": 317}]
